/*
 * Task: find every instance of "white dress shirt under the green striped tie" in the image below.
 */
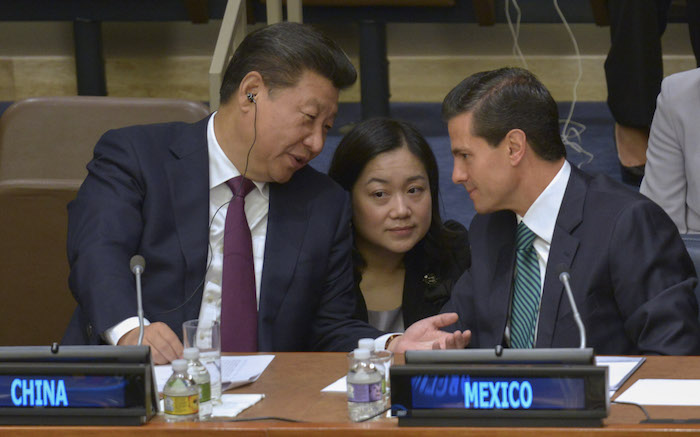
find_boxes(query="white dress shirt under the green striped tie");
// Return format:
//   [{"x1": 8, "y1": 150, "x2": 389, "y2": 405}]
[{"x1": 505, "y1": 161, "x2": 571, "y2": 344}]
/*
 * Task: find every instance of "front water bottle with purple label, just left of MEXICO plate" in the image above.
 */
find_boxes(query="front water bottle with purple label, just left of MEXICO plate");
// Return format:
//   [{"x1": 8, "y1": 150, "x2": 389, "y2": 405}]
[{"x1": 347, "y1": 349, "x2": 385, "y2": 422}]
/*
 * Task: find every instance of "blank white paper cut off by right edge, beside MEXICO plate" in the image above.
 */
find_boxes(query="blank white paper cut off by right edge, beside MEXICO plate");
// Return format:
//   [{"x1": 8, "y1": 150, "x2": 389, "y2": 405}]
[{"x1": 615, "y1": 379, "x2": 700, "y2": 407}]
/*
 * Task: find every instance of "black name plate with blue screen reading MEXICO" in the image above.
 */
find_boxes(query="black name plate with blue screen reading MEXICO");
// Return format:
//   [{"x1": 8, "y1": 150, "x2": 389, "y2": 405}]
[{"x1": 390, "y1": 352, "x2": 610, "y2": 426}]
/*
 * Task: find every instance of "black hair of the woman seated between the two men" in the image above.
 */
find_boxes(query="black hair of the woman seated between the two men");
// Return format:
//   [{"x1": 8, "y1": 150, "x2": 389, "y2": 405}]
[{"x1": 328, "y1": 118, "x2": 460, "y2": 274}]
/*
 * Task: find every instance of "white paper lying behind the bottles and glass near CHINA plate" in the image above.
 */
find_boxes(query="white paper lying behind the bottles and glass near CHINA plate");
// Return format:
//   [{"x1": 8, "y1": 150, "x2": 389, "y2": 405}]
[{"x1": 154, "y1": 355, "x2": 275, "y2": 392}]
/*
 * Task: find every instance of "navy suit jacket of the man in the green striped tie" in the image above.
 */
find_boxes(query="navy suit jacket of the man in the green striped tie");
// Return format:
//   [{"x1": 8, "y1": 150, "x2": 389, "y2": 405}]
[{"x1": 443, "y1": 166, "x2": 700, "y2": 355}]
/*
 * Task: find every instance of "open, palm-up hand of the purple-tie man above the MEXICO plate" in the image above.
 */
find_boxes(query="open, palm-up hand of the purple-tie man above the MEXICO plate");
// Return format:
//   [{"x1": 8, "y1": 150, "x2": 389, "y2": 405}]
[{"x1": 388, "y1": 313, "x2": 472, "y2": 353}]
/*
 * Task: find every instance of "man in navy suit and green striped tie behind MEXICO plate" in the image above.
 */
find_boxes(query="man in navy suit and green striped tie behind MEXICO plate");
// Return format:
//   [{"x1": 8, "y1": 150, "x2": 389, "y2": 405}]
[{"x1": 443, "y1": 68, "x2": 700, "y2": 355}]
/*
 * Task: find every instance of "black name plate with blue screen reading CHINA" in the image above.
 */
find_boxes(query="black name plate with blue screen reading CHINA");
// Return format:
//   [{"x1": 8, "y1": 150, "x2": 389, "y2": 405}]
[{"x1": 0, "y1": 346, "x2": 157, "y2": 425}]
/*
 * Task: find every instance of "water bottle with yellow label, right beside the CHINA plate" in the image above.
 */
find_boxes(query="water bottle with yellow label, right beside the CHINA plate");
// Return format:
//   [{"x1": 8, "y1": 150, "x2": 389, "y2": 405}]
[{"x1": 163, "y1": 360, "x2": 199, "y2": 422}]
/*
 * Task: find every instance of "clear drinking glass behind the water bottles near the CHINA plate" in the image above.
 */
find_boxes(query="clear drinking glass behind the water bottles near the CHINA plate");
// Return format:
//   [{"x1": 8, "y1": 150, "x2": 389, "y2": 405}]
[{"x1": 182, "y1": 319, "x2": 221, "y2": 404}]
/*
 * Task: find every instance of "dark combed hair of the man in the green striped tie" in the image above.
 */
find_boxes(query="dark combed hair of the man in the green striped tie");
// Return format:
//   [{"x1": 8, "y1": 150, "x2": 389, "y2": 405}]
[{"x1": 442, "y1": 67, "x2": 566, "y2": 161}]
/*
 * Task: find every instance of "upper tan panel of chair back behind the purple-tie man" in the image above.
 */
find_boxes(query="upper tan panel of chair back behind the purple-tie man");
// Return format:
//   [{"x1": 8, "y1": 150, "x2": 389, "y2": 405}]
[{"x1": 0, "y1": 96, "x2": 209, "y2": 181}]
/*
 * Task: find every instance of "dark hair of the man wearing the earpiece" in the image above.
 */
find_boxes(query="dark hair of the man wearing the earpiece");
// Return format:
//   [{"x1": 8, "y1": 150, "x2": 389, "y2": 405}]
[{"x1": 219, "y1": 22, "x2": 357, "y2": 103}]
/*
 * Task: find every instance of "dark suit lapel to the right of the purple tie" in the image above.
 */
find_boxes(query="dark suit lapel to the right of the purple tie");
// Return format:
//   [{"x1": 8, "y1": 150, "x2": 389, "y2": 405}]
[{"x1": 258, "y1": 181, "x2": 308, "y2": 342}]
